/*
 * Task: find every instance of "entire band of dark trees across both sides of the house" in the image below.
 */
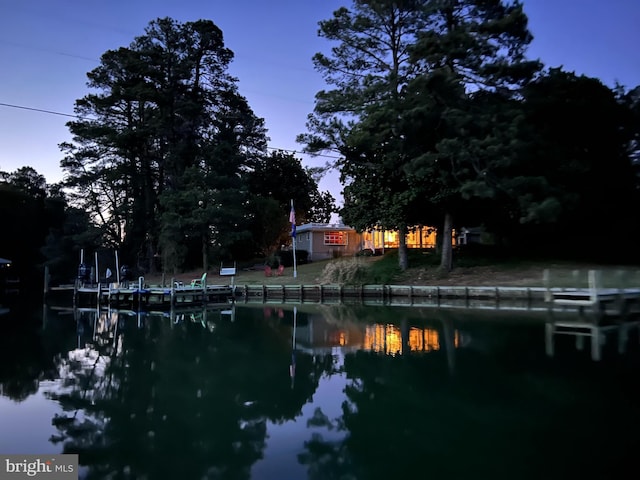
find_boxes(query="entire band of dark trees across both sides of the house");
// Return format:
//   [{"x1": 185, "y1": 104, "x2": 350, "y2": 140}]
[{"x1": 5, "y1": 7, "x2": 640, "y2": 278}]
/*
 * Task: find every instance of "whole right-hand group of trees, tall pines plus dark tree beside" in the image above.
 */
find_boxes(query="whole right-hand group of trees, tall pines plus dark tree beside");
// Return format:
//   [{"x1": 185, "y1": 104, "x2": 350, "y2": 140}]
[{"x1": 298, "y1": 0, "x2": 637, "y2": 271}]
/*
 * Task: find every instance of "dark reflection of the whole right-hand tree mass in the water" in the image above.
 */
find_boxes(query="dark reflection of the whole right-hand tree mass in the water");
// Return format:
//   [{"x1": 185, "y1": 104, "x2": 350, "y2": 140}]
[{"x1": 299, "y1": 316, "x2": 640, "y2": 480}]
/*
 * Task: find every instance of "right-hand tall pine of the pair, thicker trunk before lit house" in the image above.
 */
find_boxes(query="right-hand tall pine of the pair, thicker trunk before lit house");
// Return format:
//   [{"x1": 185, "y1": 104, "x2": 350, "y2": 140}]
[{"x1": 408, "y1": 0, "x2": 540, "y2": 271}]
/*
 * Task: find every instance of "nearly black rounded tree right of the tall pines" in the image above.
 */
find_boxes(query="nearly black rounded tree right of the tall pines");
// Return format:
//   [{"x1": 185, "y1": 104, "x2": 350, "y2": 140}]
[{"x1": 499, "y1": 69, "x2": 634, "y2": 258}]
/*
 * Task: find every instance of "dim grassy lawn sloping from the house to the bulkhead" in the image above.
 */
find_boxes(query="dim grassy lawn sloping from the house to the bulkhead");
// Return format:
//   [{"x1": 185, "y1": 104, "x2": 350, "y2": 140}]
[{"x1": 147, "y1": 250, "x2": 640, "y2": 287}]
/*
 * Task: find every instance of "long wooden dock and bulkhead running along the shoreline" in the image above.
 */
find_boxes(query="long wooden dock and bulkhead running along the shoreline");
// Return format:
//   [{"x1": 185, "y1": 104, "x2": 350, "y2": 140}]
[{"x1": 50, "y1": 266, "x2": 640, "y2": 316}]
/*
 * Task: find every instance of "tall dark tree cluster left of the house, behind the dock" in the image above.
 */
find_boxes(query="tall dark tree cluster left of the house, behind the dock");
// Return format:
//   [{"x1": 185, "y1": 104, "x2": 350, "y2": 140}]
[{"x1": 62, "y1": 18, "x2": 266, "y2": 269}]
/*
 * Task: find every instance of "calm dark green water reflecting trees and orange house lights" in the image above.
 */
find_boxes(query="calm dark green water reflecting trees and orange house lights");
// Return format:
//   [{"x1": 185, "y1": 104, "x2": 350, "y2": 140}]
[{"x1": 0, "y1": 298, "x2": 640, "y2": 480}]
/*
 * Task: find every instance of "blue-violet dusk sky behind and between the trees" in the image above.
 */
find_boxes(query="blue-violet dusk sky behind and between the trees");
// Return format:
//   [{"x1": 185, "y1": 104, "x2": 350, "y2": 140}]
[{"x1": 0, "y1": 0, "x2": 640, "y2": 203}]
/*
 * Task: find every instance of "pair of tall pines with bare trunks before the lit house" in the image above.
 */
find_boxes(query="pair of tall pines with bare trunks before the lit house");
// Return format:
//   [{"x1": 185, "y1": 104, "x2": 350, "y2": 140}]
[{"x1": 300, "y1": 0, "x2": 538, "y2": 271}]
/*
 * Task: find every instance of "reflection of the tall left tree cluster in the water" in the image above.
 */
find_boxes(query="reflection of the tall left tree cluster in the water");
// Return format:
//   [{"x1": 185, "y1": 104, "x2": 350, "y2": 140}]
[{"x1": 45, "y1": 306, "x2": 325, "y2": 478}]
